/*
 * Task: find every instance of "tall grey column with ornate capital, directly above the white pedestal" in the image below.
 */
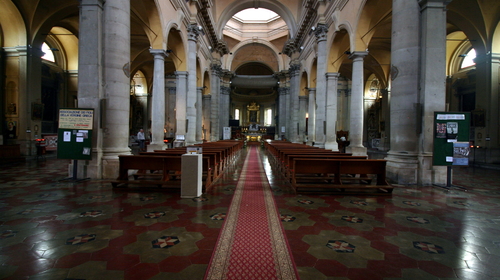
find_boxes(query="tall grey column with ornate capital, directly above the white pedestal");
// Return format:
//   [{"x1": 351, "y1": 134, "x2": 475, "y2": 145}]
[{"x1": 186, "y1": 24, "x2": 201, "y2": 145}]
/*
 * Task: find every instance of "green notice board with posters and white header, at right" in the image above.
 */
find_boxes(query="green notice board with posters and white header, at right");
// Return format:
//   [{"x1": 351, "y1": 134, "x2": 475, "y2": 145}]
[{"x1": 433, "y1": 112, "x2": 470, "y2": 166}]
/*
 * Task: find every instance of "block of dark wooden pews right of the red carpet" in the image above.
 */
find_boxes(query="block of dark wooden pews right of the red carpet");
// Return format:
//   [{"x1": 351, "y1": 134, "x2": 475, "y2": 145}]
[{"x1": 264, "y1": 141, "x2": 393, "y2": 194}]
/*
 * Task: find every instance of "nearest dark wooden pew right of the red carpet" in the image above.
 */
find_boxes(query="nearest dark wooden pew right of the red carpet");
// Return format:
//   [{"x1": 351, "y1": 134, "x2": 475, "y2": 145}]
[{"x1": 291, "y1": 158, "x2": 393, "y2": 194}]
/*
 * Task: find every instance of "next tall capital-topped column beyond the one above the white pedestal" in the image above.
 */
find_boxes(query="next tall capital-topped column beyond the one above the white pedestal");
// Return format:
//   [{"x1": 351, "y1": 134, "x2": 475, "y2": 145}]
[{"x1": 210, "y1": 62, "x2": 222, "y2": 142}]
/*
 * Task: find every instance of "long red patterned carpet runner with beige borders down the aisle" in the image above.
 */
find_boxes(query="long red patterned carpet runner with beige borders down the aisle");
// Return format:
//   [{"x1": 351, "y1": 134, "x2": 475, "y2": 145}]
[{"x1": 205, "y1": 146, "x2": 299, "y2": 280}]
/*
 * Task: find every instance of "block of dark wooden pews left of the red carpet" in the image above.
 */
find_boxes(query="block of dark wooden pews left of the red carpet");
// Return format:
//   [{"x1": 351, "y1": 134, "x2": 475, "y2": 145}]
[{"x1": 111, "y1": 140, "x2": 244, "y2": 190}]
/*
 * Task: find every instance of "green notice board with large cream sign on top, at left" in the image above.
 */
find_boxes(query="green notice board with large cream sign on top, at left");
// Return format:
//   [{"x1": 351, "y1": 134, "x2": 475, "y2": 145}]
[{"x1": 57, "y1": 108, "x2": 94, "y2": 160}]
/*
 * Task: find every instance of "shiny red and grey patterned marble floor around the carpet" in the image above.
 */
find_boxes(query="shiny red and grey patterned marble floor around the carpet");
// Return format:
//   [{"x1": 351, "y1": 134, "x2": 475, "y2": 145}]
[{"x1": 0, "y1": 150, "x2": 500, "y2": 280}]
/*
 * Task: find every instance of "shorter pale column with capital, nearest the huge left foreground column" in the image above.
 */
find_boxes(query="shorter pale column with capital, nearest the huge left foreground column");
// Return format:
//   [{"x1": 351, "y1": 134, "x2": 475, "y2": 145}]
[{"x1": 148, "y1": 49, "x2": 168, "y2": 151}]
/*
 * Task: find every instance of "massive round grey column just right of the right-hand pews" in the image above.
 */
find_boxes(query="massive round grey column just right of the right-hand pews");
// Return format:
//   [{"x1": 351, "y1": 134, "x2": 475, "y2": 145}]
[{"x1": 387, "y1": 0, "x2": 420, "y2": 184}]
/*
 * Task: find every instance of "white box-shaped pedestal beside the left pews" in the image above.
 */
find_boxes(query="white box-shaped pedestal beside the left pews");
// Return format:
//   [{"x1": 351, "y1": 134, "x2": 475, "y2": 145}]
[{"x1": 181, "y1": 154, "x2": 203, "y2": 198}]
